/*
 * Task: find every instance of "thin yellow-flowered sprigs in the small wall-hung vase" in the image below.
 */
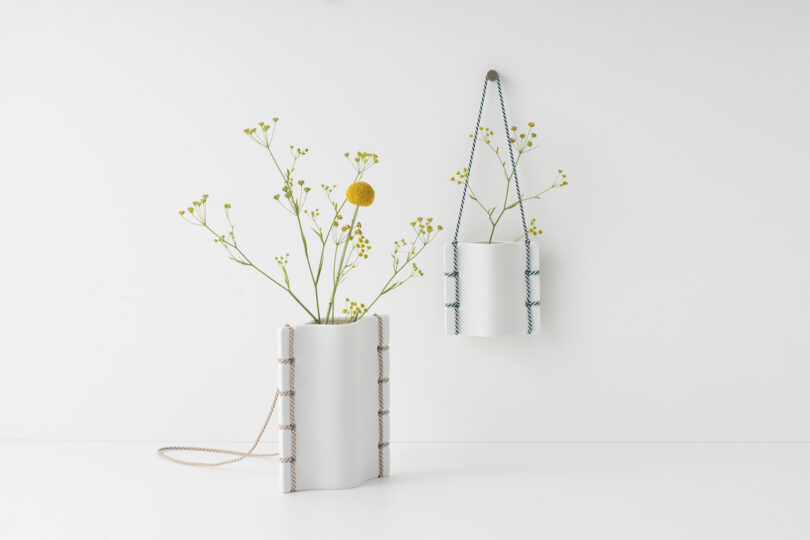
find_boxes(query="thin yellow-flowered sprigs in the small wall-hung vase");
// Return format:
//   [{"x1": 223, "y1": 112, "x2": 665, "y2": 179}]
[{"x1": 450, "y1": 122, "x2": 568, "y2": 243}]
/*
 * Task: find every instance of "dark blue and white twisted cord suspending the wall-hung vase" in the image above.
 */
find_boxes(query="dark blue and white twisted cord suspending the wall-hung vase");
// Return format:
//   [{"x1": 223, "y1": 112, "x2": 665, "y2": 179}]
[{"x1": 444, "y1": 77, "x2": 540, "y2": 335}]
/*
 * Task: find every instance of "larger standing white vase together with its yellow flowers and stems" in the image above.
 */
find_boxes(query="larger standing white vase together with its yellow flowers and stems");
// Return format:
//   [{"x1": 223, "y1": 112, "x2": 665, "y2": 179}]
[{"x1": 180, "y1": 118, "x2": 442, "y2": 492}]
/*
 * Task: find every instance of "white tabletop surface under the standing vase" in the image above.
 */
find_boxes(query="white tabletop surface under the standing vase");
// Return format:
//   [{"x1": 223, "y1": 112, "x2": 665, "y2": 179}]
[{"x1": 0, "y1": 441, "x2": 810, "y2": 540}]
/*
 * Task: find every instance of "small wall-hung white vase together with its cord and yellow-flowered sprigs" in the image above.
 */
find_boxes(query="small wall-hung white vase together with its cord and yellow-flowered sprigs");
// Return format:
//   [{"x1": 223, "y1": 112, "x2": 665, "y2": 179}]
[{"x1": 444, "y1": 79, "x2": 568, "y2": 337}]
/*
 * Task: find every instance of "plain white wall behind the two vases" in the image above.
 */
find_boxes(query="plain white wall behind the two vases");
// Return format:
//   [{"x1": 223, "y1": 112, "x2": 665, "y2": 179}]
[{"x1": 0, "y1": 1, "x2": 810, "y2": 441}]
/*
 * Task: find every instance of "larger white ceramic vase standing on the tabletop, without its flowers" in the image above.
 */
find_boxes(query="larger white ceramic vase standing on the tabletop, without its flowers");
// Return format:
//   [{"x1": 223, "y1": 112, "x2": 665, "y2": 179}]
[{"x1": 278, "y1": 315, "x2": 391, "y2": 492}]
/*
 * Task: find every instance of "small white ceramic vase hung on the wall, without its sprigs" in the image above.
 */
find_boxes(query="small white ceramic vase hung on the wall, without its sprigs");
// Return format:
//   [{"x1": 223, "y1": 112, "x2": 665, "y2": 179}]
[{"x1": 444, "y1": 241, "x2": 540, "y2": 337}]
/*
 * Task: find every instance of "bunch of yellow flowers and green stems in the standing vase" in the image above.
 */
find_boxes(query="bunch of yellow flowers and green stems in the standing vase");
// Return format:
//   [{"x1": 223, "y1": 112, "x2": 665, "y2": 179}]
[{"x1": 180, "y1": 118, "x2": 442, "y2": 324}]
